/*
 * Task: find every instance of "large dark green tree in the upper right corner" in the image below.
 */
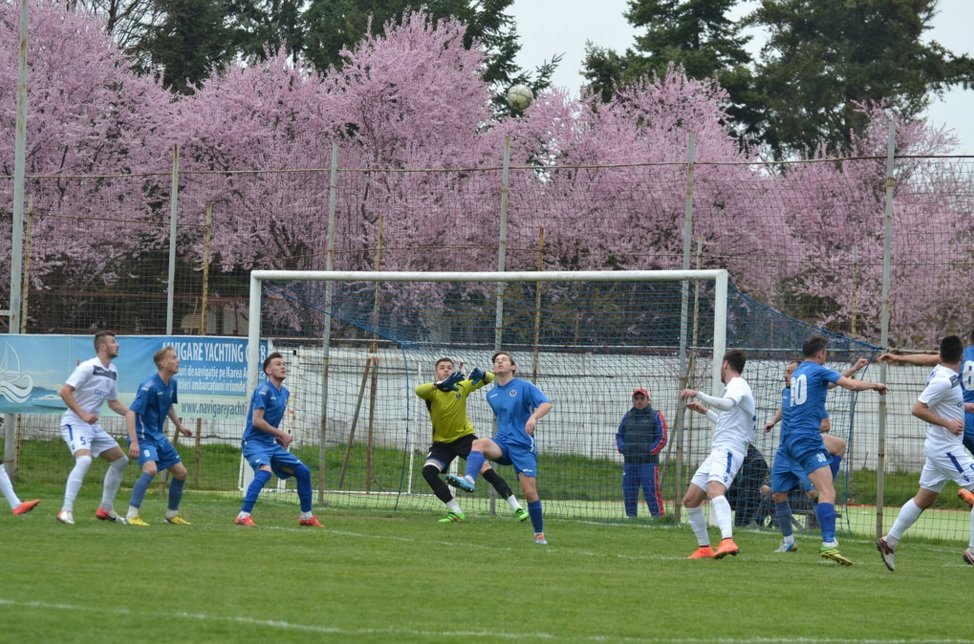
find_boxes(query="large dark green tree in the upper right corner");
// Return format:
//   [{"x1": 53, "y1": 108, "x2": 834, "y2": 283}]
[{"x1": 750, "y1": 0, "x2": 974, "y2": 156}]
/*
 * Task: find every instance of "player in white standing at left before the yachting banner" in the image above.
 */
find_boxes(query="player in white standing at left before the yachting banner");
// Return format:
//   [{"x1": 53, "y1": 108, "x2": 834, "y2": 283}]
[{"x1": 57, "y1": 331, "x2": 129, "y2": 525}]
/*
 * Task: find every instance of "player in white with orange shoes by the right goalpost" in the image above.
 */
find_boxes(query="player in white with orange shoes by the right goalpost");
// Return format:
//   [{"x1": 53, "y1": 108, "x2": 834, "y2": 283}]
[{"x1": 680, "y1": 349, "x2": 755, "y2": 559}]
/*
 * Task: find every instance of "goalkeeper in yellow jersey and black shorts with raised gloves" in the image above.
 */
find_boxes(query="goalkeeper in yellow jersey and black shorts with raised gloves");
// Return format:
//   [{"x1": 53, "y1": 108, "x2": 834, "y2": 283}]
[{"x1": 416, "y1": 358, "x2": 528, "y2": 523}]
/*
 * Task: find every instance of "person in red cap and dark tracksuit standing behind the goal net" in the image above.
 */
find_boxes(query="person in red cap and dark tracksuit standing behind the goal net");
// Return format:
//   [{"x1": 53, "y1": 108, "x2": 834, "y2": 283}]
[{"x1": 616, "y1": 387, "x2": 666, "y2": 519}]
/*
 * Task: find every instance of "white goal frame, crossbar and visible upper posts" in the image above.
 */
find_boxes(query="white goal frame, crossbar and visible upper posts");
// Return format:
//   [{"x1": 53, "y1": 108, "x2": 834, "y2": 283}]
[{"x1": 247, "y1": 269, "x2": 728, "y2": 392}]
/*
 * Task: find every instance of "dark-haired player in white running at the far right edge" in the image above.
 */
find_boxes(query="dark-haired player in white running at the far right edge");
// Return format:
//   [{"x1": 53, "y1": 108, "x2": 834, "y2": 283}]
[{"x1": 876, "y1": 335, "x2": 974, "y2": 571}]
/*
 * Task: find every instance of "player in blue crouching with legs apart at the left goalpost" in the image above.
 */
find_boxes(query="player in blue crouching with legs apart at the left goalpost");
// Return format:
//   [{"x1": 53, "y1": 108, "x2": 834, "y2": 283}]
[{"x1": 233, "y1": 351, "x2": 325, "y2": 528}]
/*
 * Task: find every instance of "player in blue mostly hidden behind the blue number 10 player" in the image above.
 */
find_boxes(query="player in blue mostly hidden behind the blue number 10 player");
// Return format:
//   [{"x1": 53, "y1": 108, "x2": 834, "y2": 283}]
[{"x1": 764, "y1": 358, "x2": 869, "y2": 552}]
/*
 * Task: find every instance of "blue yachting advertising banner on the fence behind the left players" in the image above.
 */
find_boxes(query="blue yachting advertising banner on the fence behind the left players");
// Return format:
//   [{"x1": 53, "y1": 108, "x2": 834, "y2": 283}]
[{"x1": 0, "y1": 335, "x2": 267, "y2": 418}]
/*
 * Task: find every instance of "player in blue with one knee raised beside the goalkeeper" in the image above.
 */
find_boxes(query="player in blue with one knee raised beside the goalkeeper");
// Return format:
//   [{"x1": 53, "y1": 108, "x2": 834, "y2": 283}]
[{"x1": 446, "y1": 351, "x2": 551, "y2": 545}]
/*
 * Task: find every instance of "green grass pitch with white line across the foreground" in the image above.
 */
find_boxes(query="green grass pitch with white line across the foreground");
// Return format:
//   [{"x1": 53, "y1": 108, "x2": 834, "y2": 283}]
[{"x1": 0, "y1": 486, "x2": 974, "y2": 642}]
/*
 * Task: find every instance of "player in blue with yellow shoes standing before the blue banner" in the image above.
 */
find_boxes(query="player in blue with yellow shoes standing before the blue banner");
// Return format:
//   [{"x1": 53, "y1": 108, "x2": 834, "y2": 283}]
[{"x1": 125, "y1": 347, "x2": 193, "y2": 528}]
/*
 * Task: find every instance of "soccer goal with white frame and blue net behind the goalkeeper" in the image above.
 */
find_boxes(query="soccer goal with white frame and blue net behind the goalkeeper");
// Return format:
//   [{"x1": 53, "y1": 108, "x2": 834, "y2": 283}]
[{"x1": 244, "y1": 270, "x2": 874, "y2": 520}]
